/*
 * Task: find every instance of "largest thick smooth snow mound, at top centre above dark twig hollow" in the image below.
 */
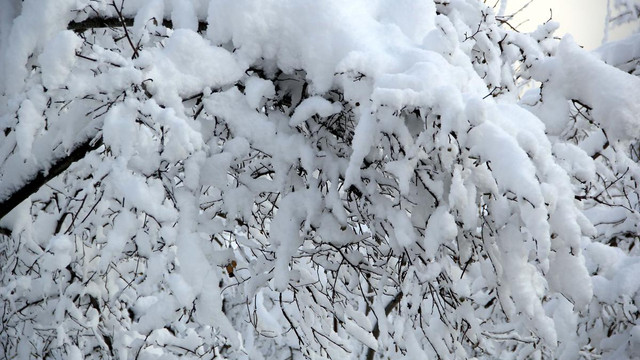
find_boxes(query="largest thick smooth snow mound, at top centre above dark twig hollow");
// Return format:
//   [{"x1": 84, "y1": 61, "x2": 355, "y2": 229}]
[{"x1": 207, "y1": 0, "x2": 444, "y2": 93}]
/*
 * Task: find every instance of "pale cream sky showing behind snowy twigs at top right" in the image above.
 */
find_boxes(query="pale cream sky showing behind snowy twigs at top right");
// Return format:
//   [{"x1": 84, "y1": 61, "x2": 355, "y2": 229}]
[{"x1": 496, "y1": 0, "x2": 640, "y2": 49}]
